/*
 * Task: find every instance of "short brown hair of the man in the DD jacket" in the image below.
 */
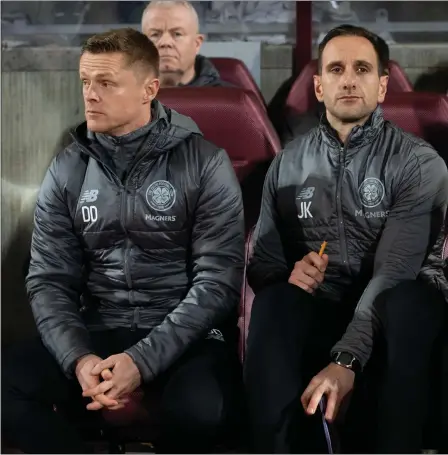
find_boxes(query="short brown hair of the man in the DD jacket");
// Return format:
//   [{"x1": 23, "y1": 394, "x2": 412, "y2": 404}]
[{"x1": 81, "y1": 28, "x2": 159, "y2": 77}]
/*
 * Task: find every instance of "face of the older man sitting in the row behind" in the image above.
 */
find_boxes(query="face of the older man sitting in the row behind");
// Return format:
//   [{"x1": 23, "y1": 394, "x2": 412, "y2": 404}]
[{"x1": 142, "y1": 5, "x2": 204, "y2": 85}]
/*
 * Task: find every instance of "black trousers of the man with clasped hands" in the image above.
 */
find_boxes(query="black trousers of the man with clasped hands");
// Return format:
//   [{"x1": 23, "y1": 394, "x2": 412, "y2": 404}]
[{"x1": 2, "y1": 329, "x2": 242, "y2": 453}]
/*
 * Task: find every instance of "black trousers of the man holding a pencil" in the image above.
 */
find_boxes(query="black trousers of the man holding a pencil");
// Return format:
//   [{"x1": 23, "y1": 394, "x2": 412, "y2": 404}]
[{"x1": 244, "y1": 281, "x2": 445, "y2": 453}]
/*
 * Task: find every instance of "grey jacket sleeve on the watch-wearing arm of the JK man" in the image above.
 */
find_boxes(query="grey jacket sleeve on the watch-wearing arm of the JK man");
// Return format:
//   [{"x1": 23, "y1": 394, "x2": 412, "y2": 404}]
[{"x1": 332, "y1": 147, "x2": 448, "y2": 366}]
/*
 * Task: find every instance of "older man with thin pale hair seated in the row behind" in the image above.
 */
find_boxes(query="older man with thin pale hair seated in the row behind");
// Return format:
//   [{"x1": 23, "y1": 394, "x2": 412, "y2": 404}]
[{"x1": 142, "y1": 0, "x2": 231, "y2": 87}]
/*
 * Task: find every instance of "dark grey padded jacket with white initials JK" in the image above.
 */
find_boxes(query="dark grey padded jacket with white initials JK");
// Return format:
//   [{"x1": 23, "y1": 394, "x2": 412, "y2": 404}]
[{"x1": 248, "y1": 107, "x2": 448, "y2": 366}]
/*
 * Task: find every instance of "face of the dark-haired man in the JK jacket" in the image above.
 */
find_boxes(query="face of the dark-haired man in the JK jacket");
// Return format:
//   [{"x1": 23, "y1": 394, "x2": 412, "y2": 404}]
[{"x1": 314, "y1": 36, "x2": 388, "y2": 123}]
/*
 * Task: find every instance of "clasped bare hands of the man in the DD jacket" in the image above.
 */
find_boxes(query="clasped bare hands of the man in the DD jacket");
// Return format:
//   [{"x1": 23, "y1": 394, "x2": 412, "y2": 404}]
[{"x1": 76, "y1": 353, "x2": 141, "y2": 411}]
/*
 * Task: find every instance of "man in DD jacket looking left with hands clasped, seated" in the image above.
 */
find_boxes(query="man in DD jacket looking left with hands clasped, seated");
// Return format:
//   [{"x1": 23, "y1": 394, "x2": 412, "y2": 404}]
[{"x1": 2, "y1": 29, "x2": 244, "y2": 453}]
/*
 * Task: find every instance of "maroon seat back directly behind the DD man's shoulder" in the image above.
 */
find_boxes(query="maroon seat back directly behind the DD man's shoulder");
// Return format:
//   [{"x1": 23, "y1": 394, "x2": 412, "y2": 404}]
[{"x1": 158, "y1": 87, "x2": 280, "y2": 229}]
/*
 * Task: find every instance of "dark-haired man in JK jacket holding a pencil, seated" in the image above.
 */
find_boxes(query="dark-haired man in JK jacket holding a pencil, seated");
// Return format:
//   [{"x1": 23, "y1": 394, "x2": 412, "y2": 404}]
[{"x1": 244, "y1": 26, "x2": 448, "y2": 453}]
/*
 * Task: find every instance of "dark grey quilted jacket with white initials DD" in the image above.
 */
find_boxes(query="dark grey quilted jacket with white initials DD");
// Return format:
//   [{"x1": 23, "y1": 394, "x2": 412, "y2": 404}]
[{"x1": 26, "y1": 101, "x2": 244, "y2": 381}]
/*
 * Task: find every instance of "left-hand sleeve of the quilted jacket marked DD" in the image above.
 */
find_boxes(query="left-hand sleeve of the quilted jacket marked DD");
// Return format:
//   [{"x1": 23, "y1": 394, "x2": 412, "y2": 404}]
[{"x1": 26, "y1": 155, "x2": 92, "y2": 377}]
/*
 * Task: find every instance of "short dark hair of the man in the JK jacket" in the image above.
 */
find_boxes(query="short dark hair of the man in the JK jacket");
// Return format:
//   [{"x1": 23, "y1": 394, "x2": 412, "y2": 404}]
[{"x1": 318, "y1": 24, "x2": 389, "y2": 76}]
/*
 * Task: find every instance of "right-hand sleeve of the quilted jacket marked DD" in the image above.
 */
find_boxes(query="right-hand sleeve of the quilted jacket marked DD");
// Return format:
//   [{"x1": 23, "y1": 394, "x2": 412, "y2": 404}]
[{"x1": 125, "y1": 150, "x2": 244, "y2": 382}]
